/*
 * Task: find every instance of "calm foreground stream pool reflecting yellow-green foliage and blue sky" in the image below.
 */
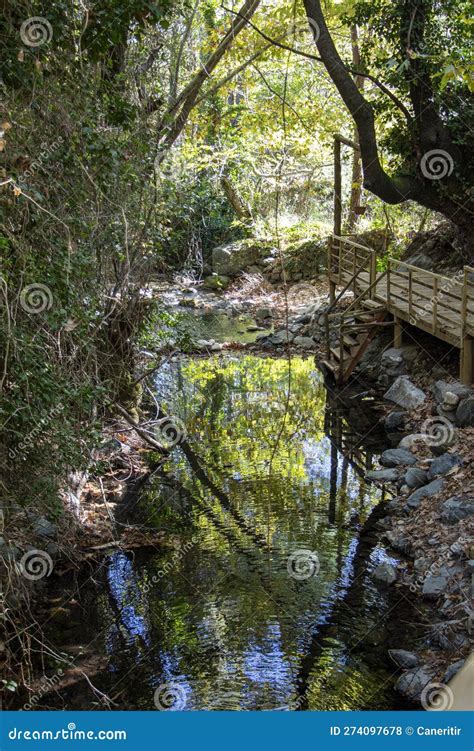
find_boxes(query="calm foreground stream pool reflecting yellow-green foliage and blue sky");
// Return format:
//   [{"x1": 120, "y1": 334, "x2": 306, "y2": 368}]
[{"x1": 39, "y1": 356, "x2": 408, "y2": 710}]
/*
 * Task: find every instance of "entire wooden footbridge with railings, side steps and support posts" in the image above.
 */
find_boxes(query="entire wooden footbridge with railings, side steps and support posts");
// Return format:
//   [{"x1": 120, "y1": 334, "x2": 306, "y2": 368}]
[{"x1": 325, "y1": 235, "x2": 474, "y2": 385}]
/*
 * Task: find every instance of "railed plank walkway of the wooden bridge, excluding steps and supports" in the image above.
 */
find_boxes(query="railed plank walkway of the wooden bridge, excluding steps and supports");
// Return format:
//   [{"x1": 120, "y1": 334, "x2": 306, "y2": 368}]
[{"x1": 328, "y1": 235, "x2": 474, "y2": 383}]
